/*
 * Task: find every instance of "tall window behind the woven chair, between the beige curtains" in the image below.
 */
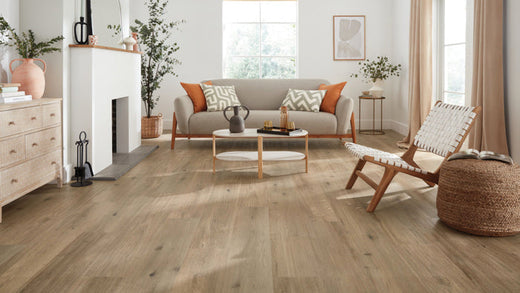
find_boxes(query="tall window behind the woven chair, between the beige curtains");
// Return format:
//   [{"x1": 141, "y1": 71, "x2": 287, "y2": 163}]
[{"x1": 437, "y1": 0, "x2": 473, "y2": 106}]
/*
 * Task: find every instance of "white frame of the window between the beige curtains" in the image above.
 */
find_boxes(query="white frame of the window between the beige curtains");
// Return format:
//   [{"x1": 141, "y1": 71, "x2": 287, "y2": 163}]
[{"x1": 433, "y1": 0, "x2": 474, "y2": 106}]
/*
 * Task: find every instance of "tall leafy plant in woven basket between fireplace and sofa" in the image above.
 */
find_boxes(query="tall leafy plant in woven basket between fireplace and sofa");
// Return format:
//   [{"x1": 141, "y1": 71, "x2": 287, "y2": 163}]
[{"x1": 130, "y1": 0, "x2": 184, "y2": 138}]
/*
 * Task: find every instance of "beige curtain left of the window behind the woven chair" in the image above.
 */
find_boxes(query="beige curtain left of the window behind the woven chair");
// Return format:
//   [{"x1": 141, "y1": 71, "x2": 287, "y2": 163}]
[{"x1": 397, "y1": 0, "x2": 433, "y2": 148}]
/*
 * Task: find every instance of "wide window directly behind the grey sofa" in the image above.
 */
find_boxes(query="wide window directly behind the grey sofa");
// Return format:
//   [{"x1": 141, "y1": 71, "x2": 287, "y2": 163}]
[{"x1": 223, "y1": 1, "x2": 297, "y2": 78}]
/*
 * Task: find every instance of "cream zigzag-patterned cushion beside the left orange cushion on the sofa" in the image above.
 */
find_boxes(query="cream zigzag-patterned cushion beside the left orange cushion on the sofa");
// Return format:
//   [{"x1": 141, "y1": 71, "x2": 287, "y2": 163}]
[{"x1": 200, "y1": 83, "x2": 240, "y2": 112}]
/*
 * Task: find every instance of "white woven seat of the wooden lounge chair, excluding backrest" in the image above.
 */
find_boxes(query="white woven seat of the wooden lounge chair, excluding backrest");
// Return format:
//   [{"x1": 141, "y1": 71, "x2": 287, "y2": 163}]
[{"x1": 345, "y1": 142, "x2": 428, "y2": 174}]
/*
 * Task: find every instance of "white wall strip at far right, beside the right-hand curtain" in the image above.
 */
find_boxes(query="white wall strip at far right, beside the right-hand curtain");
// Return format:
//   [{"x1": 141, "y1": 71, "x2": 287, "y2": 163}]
[{"x1": 504, "y1": 0, "x2": 520, "y2": 161}]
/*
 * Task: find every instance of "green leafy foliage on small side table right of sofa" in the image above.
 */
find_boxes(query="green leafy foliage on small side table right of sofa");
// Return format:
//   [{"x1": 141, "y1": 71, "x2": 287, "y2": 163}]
[{"x1": 350, "y1": 56, "x2": 401, "y2": 82}]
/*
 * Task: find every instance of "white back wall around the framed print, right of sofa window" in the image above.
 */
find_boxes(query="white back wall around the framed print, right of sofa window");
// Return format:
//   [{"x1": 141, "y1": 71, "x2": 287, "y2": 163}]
[{"x1": 298, "y1": 0, "x2": 400, "y2": 128}]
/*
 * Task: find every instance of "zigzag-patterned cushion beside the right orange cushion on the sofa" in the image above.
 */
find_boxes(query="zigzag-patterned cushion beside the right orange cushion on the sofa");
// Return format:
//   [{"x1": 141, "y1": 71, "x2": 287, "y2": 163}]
[{"x1": 282, "y1": 89, "x2": 327, "y2": 112}]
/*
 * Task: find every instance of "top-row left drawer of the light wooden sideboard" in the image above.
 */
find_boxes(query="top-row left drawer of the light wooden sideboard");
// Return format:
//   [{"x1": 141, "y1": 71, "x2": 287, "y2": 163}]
[{"x1": 0, "y1": 107, "x2": 43, "y2": 137}]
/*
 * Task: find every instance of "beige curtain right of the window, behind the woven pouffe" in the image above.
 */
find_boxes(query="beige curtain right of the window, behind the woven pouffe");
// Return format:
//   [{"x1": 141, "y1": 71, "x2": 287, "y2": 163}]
[{"x1": 469, "y1": 0, "x2": 510, "y2": 154}]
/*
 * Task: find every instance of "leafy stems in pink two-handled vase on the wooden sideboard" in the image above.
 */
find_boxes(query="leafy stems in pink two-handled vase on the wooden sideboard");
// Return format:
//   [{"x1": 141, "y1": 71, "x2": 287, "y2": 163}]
[{"x1": 0, "y1": 16, "x2": 63, "y2": 99}]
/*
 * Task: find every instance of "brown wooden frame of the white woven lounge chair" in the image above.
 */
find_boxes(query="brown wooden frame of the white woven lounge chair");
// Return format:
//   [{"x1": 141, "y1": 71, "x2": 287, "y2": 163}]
[{"x1": 345, "y1": 101, "x2": 481, "y2": 213}]
